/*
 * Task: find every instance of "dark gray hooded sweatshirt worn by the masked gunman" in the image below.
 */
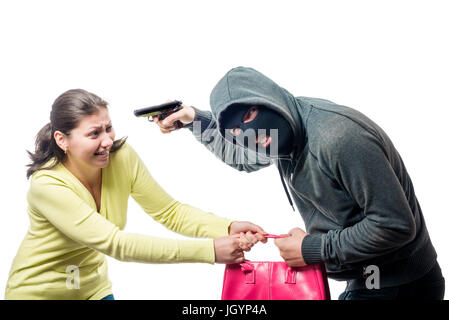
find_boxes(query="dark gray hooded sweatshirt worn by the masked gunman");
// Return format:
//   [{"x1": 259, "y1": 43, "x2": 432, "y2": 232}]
[{"x1": 188, "y1": 67, "x2": 436, "y2": 289}]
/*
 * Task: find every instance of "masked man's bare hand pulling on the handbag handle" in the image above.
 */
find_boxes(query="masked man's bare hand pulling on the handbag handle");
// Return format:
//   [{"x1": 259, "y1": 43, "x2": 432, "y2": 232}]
[{"x1": 274, "y1": 228, "x2": 307, "y2": 267}]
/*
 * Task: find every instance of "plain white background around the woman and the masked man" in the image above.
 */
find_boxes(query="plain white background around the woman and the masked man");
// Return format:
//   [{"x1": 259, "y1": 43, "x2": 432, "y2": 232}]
[{"x1": 0, "y1": 0, "x2": 449, "y2": 299}]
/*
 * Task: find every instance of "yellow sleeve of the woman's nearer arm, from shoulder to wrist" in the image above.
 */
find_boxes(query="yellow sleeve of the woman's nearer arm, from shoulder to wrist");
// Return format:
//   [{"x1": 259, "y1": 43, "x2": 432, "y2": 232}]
[{"x1": 29, "y1": 174, "x2": 215, "y2": 263}]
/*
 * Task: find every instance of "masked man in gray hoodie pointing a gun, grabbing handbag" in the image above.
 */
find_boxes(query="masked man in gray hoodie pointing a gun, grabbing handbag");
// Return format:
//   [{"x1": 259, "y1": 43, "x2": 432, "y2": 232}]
[{"x1": 156, "y1": 67, "x2": 444, "y2": 299}]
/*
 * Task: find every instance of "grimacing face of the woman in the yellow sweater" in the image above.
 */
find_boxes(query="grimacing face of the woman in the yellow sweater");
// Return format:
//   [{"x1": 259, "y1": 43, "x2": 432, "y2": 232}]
[{"x1": 67, "y1": 107, "x2": 115, "y2": 168}]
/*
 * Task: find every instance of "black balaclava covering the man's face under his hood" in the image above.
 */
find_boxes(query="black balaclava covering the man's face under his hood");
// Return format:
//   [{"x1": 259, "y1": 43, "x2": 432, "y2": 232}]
[{"x1": 220, "y1": 104, "x2": 294, "y2": 157}]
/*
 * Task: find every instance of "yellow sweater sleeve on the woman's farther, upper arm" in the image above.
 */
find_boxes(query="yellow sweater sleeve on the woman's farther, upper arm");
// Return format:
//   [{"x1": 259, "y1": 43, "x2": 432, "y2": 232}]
[{"x1": 128, "y1": 142, "x2": 232, "y2": 238}]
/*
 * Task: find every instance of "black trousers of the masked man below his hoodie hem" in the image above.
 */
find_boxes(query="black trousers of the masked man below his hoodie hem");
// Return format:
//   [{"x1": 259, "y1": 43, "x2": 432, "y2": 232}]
[{"x1": 338, "y1": 262, "x2": 445, "y2": 300}]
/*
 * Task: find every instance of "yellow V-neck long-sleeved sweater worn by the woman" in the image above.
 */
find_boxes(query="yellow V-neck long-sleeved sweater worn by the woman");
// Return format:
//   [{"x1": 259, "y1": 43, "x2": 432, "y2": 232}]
[{"x1": 5, "y1": 143, "x2": 231, "y2": 299}]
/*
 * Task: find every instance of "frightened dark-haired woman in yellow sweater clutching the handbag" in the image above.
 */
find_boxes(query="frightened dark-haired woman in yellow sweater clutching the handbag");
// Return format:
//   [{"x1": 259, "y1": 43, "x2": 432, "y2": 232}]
[{"x1": 5, "y1": 89, "x2": 266, "y2": 299}]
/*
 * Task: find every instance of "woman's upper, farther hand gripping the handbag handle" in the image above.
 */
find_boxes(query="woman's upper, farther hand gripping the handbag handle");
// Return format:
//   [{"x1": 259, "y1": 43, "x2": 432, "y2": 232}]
[{"x1": 229, "y1": 221, "x2": 267, "y2": 251}]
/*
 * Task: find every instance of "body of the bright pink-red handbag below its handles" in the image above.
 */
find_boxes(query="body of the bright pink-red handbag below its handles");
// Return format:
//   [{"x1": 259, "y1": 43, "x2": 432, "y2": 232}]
[{"x1": 221, "y1": 261, "x2": 330, "y2": 300}]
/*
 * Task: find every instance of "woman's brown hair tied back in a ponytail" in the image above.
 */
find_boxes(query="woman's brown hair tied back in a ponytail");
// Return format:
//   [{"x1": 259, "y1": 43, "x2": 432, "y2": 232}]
[{"x1": 27, "y1": 89, "x2": 127, "y2": 179}]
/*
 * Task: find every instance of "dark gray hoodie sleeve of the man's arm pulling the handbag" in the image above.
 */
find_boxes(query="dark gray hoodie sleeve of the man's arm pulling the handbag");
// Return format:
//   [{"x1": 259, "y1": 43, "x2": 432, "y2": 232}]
[{"x1": 302, "y1": 131, "x2": 416, "y2": 264}]
